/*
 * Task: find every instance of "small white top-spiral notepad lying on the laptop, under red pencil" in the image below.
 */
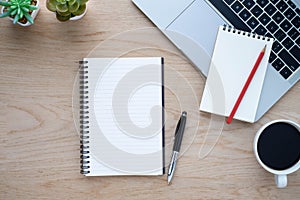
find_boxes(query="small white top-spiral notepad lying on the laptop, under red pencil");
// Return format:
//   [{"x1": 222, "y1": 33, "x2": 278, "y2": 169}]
[{"x1": 200, "y1": 26, "x2": 273, "y2": 123}]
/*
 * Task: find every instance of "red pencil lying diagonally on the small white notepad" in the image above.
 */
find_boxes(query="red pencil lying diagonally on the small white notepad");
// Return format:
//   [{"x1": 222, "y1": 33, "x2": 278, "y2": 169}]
[{"x1": 226, "y1": 45, "x2": 267, "y2": 124}]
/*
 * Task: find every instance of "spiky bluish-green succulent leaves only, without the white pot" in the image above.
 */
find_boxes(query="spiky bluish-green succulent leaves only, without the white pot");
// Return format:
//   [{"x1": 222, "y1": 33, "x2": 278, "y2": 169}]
[{"x1": 0, "y1": 0, "x2": 38, "y2": 24}]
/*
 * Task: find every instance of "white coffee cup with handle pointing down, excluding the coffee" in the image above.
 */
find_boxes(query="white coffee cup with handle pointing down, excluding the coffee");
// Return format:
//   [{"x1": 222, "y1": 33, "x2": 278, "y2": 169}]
[{"x1": 253, "y1": 119, "x2": 300, "y2": 188}]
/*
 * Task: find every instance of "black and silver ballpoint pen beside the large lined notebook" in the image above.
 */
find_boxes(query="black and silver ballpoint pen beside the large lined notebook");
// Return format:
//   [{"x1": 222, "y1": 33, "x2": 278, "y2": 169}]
[{"x1": 168, "y1": 111, "x2": 187, "y2": 184}]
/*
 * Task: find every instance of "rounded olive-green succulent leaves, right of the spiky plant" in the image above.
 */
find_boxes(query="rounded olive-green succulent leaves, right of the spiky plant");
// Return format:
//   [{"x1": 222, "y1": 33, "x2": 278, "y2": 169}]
[{"x1": 46, "y1": 0, "x2": 88, "y2": 21}]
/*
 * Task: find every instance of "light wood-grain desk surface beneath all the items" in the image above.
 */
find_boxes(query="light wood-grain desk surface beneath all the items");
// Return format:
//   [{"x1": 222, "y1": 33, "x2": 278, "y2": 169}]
[{"x1": 0, "y1": 0, "x2": 300, "y2": 200}]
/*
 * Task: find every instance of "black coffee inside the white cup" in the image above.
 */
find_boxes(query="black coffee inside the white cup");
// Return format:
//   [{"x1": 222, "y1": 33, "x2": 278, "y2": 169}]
[{"x1": 257, "y1": 122, "x2": 300, "y2": 170}]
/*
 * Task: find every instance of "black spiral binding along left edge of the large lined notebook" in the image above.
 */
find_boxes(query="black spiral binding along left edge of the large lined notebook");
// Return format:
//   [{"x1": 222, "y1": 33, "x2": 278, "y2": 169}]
[{"x1": 79, "y1": 61, "x2": 90, "y2": 174}]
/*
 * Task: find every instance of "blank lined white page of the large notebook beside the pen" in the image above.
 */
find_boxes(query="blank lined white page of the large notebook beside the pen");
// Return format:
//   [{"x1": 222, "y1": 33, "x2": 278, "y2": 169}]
[{"x1": 85, "y1": 58, "x2": 163, "y2": 176}]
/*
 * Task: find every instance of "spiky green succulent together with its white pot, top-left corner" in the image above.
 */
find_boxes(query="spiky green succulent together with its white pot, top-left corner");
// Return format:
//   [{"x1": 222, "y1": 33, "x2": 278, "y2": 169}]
[{"x1": 0, "y1": 0, "x2": 39, "y2": 26}]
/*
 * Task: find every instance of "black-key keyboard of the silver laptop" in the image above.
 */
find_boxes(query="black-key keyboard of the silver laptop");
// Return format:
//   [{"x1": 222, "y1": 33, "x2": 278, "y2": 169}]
[{"x1": 209, "y1": 0, "x2": 300, "y2": 79}]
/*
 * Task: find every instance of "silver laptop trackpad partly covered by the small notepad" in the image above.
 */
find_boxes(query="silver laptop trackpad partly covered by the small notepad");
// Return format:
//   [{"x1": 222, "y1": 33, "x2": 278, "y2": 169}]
[{"x1": 164, "y1": 0, "x2": 225, "y2": 76}]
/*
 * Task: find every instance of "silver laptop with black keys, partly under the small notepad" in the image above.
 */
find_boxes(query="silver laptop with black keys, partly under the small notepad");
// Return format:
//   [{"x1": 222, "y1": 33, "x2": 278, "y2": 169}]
[{"x1": 132, "y1": 0, "x2": 300, "y2": 121}]
